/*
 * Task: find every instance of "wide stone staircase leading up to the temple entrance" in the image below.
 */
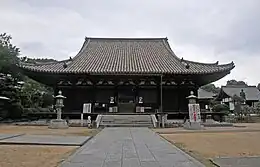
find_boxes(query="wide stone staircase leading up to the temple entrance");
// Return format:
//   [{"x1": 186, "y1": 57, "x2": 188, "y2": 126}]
[{"x1": 96, "y1": 114, "x2": 156, "y2": 128}]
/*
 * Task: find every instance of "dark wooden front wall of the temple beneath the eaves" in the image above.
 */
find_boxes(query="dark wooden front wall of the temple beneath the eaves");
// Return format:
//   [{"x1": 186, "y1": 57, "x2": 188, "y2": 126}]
[{"x1": 55, "y1": 76, "x2": 197, "y2": 113}]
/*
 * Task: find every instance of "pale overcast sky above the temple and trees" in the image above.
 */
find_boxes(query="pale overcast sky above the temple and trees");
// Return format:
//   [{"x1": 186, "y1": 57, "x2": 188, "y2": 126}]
[{"x1": 0, "y1": 0, "x2": 260, "y2": 85}]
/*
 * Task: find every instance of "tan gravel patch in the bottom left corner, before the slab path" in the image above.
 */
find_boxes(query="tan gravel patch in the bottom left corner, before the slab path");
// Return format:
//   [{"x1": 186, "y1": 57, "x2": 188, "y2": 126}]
[{"x1": 0, "y1": 145, "x2": 78, "y2": 167}]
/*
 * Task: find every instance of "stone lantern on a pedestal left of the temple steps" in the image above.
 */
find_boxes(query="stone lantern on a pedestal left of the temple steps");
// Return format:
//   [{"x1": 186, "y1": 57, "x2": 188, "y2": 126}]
[{"x1": 49, "y1": 91, "x2": 68, "y2": 129}]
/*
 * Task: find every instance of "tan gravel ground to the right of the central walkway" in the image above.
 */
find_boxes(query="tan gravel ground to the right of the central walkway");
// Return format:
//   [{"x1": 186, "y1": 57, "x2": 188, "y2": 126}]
[{"x1": 164, "y1": 132, "x2": 260, "y2": 158}]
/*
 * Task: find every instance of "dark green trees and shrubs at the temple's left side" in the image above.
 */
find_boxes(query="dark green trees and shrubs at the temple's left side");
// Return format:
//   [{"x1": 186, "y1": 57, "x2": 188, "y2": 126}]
[{"x1": 0, "y1": 33, "x2": 54, "y2": 119}]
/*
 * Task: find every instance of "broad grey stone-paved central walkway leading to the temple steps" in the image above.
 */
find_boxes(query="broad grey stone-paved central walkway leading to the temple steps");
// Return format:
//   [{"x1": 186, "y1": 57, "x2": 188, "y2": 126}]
[{"x1": 61, "y1": 128, "x2": 203, "y2": 167}]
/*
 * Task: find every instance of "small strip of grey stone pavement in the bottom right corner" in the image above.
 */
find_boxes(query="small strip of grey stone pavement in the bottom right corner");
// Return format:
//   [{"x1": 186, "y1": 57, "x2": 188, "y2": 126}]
[{"x1": 213, "y1": 157, "x2": 260, "y2": 167}]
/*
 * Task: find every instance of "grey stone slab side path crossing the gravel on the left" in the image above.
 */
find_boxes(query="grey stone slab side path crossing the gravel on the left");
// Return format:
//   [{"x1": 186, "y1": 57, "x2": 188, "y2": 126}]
[{"x1": 0, "y1": 135, "x2": 90, "y2": 146}]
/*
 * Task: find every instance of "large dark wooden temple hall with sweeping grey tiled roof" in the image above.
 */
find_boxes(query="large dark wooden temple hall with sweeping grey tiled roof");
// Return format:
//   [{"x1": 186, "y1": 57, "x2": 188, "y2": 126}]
[{"x1": 20, "y1": 37, "x2": 235, "y2": 118}]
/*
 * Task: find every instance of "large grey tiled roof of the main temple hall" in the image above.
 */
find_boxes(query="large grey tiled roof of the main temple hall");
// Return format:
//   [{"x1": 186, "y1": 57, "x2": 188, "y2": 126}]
[{"x1": 21, "y1": 38, "x2": 234, "y2": 74}]
